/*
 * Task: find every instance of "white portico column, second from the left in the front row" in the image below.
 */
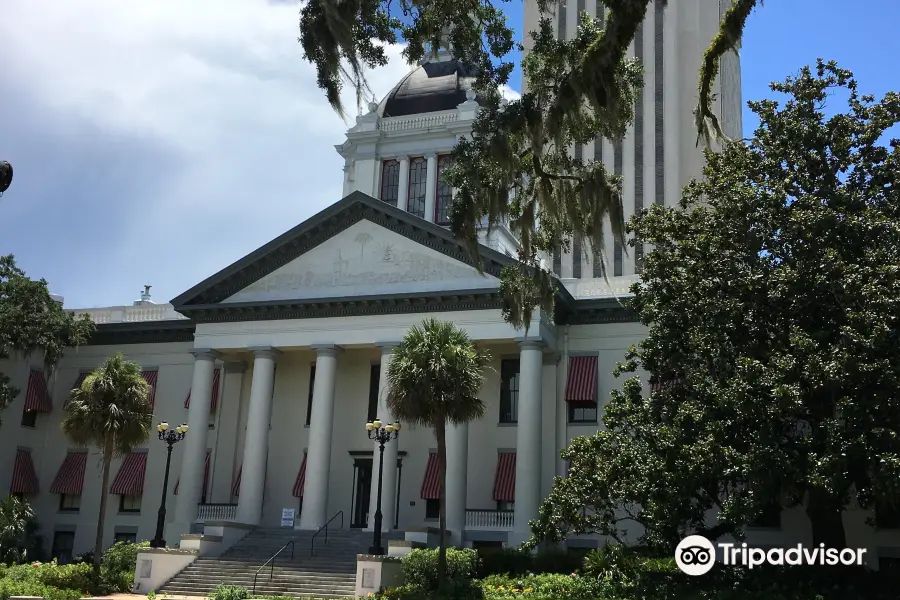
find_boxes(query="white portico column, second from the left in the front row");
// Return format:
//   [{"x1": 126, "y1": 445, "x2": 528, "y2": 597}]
[{"x1": 234, "y1": 347, "x2": 280, "y2": 525}]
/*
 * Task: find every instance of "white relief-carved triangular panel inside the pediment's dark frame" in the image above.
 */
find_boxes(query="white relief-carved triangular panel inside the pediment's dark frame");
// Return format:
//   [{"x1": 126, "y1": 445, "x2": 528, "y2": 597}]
[{"x1": 223, "y1": 219, "x2": 498, "y2": 303}]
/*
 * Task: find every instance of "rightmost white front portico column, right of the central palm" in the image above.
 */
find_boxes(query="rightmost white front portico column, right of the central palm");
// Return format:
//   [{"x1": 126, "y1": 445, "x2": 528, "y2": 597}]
[{"x1": 509, "y1": 340, "x2": 544, "y2": 545}]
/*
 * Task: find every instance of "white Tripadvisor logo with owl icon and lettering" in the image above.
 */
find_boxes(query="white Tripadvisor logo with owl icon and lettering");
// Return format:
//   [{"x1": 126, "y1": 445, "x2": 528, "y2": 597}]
[{"x1": 675, "y1": 535, "x2": 866, "y2": 575}]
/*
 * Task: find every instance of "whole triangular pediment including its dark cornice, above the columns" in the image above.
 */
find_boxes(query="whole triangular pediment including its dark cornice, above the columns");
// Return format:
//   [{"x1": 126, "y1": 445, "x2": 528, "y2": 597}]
[{"x1": 172, "y1": 192, "x2": 515, "y2": 314}]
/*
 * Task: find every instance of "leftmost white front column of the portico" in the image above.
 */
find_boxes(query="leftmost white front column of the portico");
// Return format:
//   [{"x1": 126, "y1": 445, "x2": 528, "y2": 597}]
[{"x1": 170, "y1": 349, "x2": 219, "y2": 536}]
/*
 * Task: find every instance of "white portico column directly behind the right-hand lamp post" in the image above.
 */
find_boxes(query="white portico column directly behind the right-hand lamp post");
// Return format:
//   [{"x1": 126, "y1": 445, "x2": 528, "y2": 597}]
[{"x1": 368, "y1": 343, "x2": 403, "y2": 531}]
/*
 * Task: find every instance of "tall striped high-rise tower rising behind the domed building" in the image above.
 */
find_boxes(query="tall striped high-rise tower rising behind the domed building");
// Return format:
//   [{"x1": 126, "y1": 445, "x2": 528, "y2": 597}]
[{"x1": 523, "y1": 0, "x2": 742, "y2": 280}]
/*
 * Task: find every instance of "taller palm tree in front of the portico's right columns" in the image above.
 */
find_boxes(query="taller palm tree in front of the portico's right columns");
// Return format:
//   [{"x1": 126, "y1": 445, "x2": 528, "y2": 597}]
[{"x1": 386, "y1": 319, "x2": 491, "y2": 587}]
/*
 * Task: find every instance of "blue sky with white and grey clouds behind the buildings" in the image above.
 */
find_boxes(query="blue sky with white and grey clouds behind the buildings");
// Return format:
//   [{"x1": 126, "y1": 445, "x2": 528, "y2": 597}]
[{"x1": 0, "y1": 0, "x2": 900, "y2": 307}]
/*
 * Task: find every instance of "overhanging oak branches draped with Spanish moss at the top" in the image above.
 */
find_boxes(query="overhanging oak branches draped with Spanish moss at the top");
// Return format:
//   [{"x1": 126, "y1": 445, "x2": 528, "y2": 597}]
[{"x1": 300, "y1": 0, "x2": 758, "y2": 326}]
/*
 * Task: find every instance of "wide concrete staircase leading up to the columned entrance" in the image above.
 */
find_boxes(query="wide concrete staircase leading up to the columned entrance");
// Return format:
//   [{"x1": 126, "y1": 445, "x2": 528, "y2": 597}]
[{"x1": 157, "y1": 527, "x2": 403, "y2": 598}]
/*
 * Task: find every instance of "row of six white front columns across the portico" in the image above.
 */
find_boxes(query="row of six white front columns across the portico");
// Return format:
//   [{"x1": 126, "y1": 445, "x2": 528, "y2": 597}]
[{"x1": 175, "y1": 341, "x2": 543, "y2": 544}]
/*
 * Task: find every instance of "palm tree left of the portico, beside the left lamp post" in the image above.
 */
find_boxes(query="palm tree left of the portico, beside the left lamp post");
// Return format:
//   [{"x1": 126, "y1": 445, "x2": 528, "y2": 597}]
[{"x1": 62, "y1": 354, "x2": 153, "y2": 571}]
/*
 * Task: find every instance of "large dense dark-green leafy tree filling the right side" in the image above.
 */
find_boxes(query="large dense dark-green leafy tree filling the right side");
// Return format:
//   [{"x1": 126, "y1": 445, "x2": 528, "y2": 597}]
[{"x1": 533, "y1": 61, "x2": 900, "y2": 550}]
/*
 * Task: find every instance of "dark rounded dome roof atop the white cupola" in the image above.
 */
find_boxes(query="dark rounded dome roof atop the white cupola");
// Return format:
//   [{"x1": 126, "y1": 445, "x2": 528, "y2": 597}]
[{"x1": 378, "y1": 58, "x2": 479, "y2": 117}]
